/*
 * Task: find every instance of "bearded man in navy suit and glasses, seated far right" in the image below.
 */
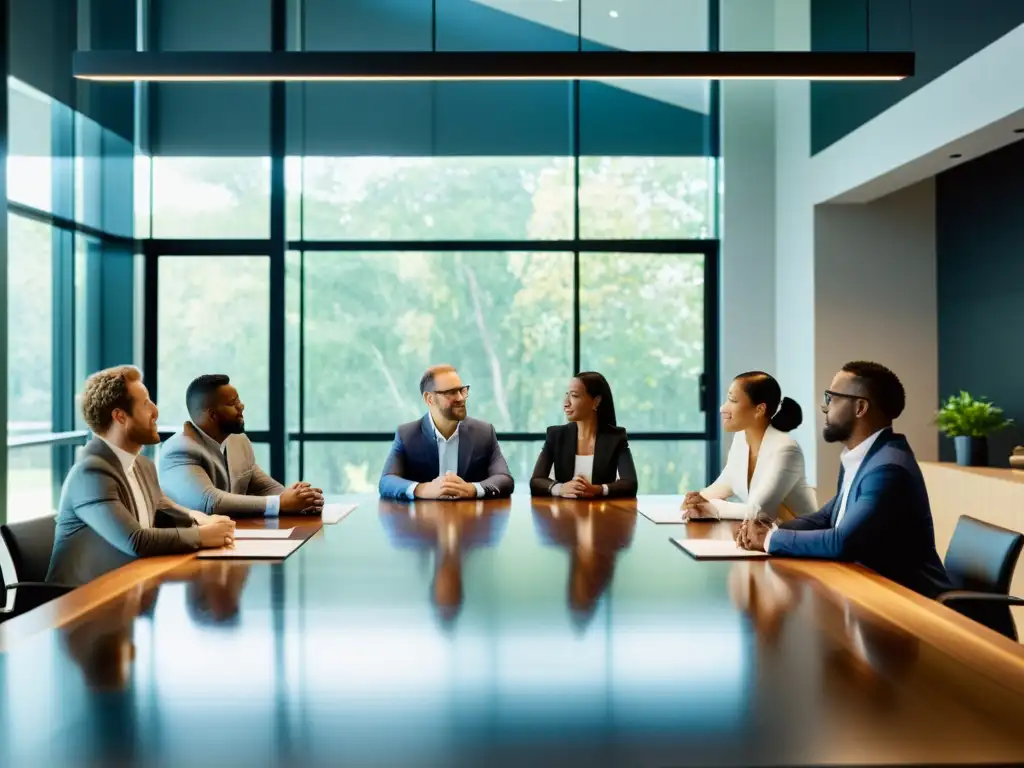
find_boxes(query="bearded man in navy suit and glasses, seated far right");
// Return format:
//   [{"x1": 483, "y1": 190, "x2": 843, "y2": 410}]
[{"x1": 736, "y1": 362, "x2": 951, "y2": 598}]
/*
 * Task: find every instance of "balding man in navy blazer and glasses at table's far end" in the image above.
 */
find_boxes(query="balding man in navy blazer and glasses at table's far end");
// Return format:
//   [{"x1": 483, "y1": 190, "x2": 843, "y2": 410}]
[{"x1": 379, "y1": 366, "x2": 514, "y2": 499}]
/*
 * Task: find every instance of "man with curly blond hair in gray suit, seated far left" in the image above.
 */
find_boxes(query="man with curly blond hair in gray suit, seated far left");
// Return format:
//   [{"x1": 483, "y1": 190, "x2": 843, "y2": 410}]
[{"x1": 46, "y1": 366, "x2": 234, "y2": 586}]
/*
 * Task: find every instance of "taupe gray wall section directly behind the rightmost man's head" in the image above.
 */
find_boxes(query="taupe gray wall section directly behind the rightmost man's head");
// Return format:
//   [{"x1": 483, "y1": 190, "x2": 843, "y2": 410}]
[{"x1": 814, "y1": 179, "x2": 938, "y2": 489}]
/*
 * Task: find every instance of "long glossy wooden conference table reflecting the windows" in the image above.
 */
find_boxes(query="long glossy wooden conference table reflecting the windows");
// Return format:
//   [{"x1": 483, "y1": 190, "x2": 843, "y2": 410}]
[{"x1": 0, "y1": 496, "x2": 1024, "y2": 768}]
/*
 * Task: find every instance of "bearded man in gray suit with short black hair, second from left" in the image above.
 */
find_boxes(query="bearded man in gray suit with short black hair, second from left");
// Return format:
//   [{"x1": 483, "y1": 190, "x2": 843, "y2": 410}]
[{"x1": 160, "y1": 374, "x2": 324, "y2": 517}]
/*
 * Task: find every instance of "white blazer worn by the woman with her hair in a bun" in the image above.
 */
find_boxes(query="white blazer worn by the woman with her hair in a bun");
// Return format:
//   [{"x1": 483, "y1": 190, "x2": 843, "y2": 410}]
[{"x1": 700, "y1": 427, "x2": 818, "y2": 520}]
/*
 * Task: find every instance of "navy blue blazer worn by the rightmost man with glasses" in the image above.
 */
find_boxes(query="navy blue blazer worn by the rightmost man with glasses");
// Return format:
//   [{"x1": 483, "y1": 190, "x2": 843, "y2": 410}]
[{"x1": 770, "y1": 430, "x2": 952, "y2": 597}]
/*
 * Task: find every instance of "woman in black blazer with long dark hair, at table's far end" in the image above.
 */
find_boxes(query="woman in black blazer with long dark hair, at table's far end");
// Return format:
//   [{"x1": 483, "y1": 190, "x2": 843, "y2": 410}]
[{"x1": 529, "y1": 371, "x2": 637, "y2": 499}]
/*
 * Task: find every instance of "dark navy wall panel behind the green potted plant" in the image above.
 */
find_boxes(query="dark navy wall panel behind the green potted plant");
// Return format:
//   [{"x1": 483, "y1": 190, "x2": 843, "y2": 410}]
[{"x1": 936, "y1": 141, "x2": 1024, "y2": 467}]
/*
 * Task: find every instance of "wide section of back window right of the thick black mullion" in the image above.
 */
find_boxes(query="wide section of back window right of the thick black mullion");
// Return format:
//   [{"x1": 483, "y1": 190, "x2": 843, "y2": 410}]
[{"x1": 286, "y1": 0, "x2": 717, "y2": 493}]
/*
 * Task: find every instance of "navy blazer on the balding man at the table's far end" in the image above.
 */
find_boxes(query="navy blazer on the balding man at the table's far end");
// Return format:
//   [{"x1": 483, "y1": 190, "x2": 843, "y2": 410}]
[{"x1": 378, "y1": 414, "x2": 515, "y2": 499}]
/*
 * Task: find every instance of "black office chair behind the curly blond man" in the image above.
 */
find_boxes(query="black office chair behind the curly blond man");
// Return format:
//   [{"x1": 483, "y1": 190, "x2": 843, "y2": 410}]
[{"x1": 0, "y1": 515, "x2": 74, "y2": 621}]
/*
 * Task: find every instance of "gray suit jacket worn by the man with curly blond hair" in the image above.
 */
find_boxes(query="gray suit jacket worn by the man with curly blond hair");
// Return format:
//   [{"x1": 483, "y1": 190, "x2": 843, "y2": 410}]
[{"x1": 46, "y1": 437, "x2": 200, "y2": 585}]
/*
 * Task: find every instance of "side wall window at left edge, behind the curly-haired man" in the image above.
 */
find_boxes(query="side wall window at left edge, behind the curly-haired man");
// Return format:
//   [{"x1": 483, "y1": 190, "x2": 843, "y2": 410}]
[{"x1": 3, "y1": 64, "x2": 133, "y2": 521}]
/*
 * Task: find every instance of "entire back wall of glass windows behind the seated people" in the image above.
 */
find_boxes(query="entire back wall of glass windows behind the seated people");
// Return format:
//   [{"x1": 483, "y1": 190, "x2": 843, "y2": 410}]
[{"x1": 135, "y1": 0, "x2": 718, "y2": 493}]
